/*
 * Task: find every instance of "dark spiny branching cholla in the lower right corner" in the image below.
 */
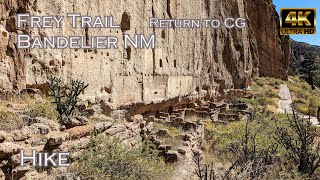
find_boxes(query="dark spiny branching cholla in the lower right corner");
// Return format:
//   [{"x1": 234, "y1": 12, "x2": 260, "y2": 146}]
[{"x1": 275, "y1": 111, "x2": 320, "y2": 176}]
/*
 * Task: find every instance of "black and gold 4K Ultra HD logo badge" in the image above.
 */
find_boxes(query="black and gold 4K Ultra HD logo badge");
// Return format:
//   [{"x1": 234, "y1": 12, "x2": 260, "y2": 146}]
[{"x1": 280, "y1": 8, "x2": 316, "y2": 35}]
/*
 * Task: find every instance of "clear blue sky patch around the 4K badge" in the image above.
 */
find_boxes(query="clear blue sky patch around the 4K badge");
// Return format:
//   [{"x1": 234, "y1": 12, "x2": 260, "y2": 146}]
[{"x1": 273, "y1": 0, "x2": 320, "y2": 46}]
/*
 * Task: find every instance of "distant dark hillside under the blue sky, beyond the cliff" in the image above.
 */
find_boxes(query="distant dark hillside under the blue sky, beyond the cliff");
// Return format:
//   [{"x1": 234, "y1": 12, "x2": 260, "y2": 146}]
[{"x1": 289, "y1": 39, "x2": 320, "y2": 75}]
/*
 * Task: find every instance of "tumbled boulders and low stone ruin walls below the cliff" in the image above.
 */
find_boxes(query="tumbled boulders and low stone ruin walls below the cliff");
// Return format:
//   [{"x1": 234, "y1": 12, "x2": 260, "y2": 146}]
[{"x1": 0, "y1": 92, "x2": 251, "y2": 180}]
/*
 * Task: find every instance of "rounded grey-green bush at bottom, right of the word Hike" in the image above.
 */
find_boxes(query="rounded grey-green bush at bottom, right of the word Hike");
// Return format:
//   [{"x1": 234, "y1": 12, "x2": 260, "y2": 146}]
[{"x1": 75, "y1": 136, "x2": 171, "y2": 179}]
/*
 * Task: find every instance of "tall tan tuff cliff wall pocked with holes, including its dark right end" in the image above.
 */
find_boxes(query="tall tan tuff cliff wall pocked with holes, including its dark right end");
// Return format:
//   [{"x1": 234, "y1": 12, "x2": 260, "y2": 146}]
[{"x1": 0, "y1": 0, "x2": 288, "y2": 108}]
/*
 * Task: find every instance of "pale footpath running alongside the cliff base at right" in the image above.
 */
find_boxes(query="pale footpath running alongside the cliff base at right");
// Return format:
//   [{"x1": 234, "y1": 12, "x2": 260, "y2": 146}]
[{"x1": 278, "y1": 84, "x2": 320, "y2": 126}]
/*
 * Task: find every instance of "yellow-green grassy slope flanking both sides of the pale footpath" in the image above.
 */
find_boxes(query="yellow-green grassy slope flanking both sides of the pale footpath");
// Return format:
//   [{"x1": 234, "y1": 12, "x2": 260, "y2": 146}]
[{"x1": 241, "y1": 76, "x2": 320, "y2": 116}]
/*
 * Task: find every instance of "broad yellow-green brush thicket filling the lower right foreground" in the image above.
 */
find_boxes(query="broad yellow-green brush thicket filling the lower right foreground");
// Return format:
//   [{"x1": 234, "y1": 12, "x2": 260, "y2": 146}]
[{"x1": 202, "y1": 110, "x2": 320, "y2": 179}]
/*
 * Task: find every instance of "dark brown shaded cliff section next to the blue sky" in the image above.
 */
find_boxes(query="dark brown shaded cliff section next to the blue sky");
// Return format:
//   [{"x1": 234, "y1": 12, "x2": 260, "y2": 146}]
[{"x1": 247, "y1": 0, "x2": 290, "y2": 79}]
